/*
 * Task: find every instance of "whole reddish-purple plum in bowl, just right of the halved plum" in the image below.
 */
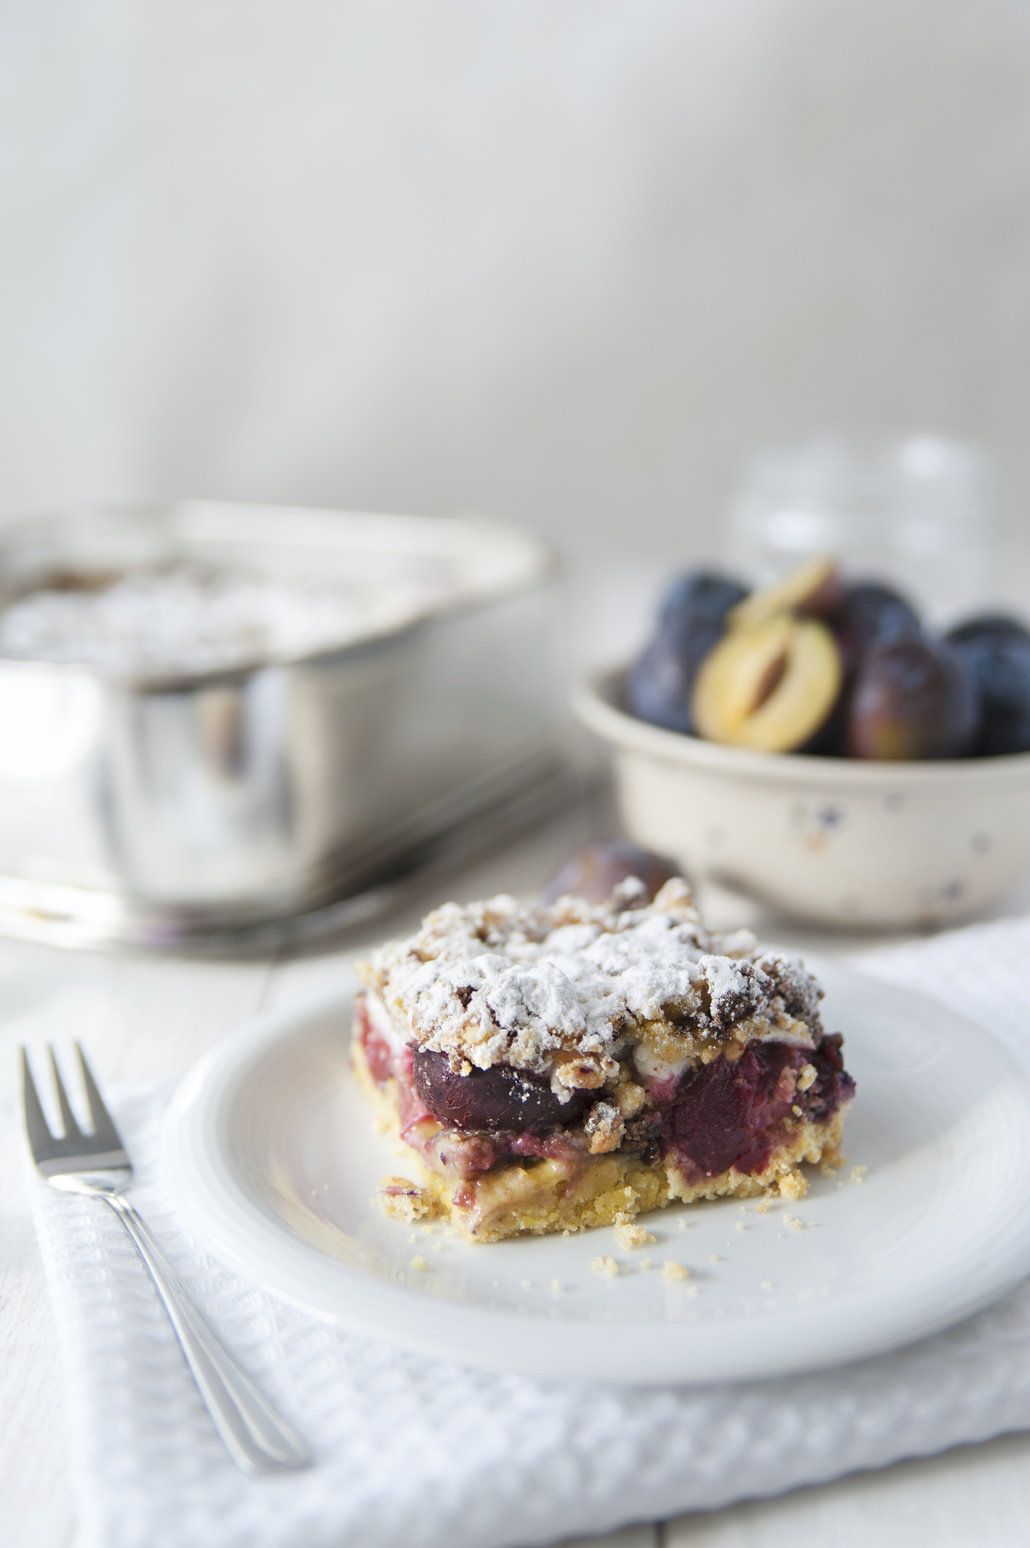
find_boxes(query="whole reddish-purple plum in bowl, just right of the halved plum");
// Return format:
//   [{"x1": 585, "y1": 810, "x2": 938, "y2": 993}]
[{"x1": 846, "y1": 638, "x2": 980, "y2": 760}]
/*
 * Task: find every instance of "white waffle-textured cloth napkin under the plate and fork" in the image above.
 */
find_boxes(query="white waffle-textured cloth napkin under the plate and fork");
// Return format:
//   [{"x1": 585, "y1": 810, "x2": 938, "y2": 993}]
[{"x1": 36, "y1": 918, "x2": 1030, "y2": 1548}]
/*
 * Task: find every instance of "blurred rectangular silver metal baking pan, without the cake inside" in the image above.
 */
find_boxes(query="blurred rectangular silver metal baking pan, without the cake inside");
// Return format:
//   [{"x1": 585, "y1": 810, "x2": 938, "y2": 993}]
[{"x1": 0, "y1": 502, "x2": 564, "y2": 949}]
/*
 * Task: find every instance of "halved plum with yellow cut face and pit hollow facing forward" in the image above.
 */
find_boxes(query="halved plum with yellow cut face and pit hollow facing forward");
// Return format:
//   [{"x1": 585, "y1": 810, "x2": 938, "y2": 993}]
[{"x1": 694, "y1": 615, "x2": 843, "y2": 752}]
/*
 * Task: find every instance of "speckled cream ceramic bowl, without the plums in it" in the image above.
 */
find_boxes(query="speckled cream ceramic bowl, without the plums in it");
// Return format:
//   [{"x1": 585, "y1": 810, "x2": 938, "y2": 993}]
[{"x1": 575, "y1": 670, "x2": 1030, "y2": 929}]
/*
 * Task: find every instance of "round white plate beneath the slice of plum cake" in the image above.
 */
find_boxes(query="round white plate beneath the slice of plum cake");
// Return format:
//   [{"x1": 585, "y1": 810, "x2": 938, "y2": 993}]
[{"x1": 164, "y1": 966, "x2": 1030, "y2": 1382}]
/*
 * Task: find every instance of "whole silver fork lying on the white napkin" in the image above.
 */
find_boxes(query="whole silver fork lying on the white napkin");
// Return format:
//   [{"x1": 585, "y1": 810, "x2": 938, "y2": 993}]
[{"x1": 22, "y1": 1043, "x2": 311, "y2": 1472}]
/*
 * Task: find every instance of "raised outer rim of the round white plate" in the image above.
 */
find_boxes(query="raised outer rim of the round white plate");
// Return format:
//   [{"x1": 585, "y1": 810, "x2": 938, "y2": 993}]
[{"x1": 161, "y1": 955, "x2": 1030, "y2": 1387}]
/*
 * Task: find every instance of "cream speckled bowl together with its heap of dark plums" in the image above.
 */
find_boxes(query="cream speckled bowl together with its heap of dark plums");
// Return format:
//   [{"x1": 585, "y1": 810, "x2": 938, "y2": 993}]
[{"x1": 576, "y1": 559, "x2": 1030, "y2": 930}]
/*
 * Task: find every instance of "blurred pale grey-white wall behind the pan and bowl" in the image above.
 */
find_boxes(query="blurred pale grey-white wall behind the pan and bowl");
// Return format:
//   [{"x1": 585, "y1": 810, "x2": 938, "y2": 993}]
[{"x1": 0, "y1": 0, "x2": 1030, "y2": 578}]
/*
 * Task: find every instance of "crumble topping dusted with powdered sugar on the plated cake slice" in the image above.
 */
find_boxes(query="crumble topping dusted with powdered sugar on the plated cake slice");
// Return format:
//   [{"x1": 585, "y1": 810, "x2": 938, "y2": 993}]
[{"x1": 359, "y1": 878, "x2": 821, "y2": 1096}]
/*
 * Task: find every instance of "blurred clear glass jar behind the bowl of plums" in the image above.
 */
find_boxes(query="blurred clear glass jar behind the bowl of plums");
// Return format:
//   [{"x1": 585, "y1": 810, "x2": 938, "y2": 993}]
[{"x1": 723, "y1": 435, "x2": 1001, "y2": 621}]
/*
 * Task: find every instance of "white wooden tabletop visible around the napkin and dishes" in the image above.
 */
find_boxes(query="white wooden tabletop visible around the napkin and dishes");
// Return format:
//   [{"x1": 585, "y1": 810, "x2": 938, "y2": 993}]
[{"x1": 0, "y1": 816, "x2": 1030, "y2": 1548}]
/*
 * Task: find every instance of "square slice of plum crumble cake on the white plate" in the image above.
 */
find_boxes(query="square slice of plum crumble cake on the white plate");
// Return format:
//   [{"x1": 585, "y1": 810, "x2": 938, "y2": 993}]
[{"x1": 352, "y1": 878, "x2": 855, "y2": 1241}]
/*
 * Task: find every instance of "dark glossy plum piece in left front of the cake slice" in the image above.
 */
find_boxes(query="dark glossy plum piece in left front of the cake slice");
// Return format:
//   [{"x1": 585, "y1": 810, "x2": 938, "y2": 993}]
[{"x1": 414, "y1": 1048, "x2": 585, "y2": 1133}]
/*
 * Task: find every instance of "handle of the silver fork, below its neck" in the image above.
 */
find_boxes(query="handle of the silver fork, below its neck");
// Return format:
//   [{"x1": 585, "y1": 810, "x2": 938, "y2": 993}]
[{"x1": 101, "y1": 1194, "x2": 311, "y2": 1472}]
